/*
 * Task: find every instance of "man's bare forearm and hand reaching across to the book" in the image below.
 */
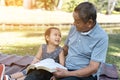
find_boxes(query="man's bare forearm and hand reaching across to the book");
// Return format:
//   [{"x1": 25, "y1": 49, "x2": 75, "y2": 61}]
[{"x1": 54, "y1": 61, "x2": 100, "y2": 78}]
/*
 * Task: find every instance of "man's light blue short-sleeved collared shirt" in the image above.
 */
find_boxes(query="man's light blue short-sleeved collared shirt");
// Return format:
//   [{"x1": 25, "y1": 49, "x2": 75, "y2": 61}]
[{"x1": 65, "y1": 23, "x2": 108, "y2": 70}]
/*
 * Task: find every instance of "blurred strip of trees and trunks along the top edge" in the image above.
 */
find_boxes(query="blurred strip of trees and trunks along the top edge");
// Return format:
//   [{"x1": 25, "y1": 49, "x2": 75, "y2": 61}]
[{"x1": 0, "y1": 0, "x2": 120, "y2": 14}]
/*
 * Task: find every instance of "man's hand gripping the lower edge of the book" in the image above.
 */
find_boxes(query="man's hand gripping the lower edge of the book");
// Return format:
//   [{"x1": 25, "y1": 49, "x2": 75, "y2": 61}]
[{"x1": 53, "y1": 68, "x2": 69, "y2": 78}]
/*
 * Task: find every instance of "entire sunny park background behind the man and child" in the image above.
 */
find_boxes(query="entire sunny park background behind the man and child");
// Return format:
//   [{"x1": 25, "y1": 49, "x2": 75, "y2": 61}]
[{"x1": 0, "y1": 0, "x2": 120, "y2": 78}]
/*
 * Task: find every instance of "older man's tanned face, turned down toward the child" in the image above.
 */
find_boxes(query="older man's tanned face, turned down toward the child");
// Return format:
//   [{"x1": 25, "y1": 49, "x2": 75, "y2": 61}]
[{"x1": 73, "y1": 12, "x2": 90, "y2": 32}]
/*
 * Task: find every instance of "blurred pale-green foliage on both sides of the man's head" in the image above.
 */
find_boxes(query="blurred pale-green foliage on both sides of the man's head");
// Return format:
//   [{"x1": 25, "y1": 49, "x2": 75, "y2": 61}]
[{"x1": 62, "y1": 0, "x2": 120, "y2": 14}]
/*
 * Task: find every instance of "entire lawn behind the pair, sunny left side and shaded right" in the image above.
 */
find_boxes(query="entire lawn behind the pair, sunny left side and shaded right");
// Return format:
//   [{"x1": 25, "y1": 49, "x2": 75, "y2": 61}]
[{"x1": 0, "y1": 26, "x2": 120, "y2": 77}]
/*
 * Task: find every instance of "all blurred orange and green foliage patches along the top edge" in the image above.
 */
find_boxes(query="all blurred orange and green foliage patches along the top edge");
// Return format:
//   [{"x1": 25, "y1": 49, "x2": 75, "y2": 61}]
[{"x1": 5, "y1": 0, "x2": 120, "y2": 14}]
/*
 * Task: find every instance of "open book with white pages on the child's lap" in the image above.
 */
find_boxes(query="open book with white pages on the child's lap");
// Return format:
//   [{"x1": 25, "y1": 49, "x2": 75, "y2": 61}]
[{"x1": 27, "y1": 58, "x2": 67, "y2": 73}]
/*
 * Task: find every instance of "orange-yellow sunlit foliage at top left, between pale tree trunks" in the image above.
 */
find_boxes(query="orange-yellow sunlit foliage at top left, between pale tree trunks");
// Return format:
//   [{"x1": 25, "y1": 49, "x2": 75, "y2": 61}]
[{"x1": 5, "y1": 0, "x2": 58, "y2": 10}]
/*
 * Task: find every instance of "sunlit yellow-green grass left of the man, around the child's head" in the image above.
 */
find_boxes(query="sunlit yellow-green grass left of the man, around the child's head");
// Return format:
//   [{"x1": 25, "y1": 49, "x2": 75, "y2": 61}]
[{"x1": 0, "y1": 27, "x2": 69, "y2": 55}]
